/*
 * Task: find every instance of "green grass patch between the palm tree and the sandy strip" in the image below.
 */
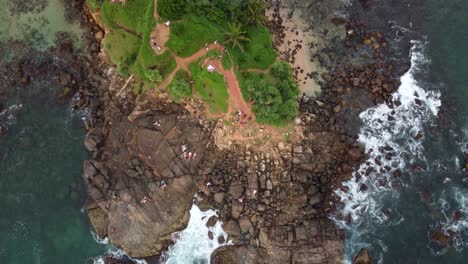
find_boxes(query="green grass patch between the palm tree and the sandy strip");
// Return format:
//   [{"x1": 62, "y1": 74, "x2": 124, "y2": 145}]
[{"x1": 228, "y1": 25, "x2": 278, "y2": 70}]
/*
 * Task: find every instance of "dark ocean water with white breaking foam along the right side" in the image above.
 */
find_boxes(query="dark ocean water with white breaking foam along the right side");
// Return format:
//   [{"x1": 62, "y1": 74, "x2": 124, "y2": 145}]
[{"x1": 334, "y1": 0, "x2": 468, "y2": 264}]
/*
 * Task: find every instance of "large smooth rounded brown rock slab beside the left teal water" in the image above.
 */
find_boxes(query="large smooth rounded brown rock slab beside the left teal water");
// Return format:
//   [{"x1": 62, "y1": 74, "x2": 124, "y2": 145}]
[{"x1": 83, "y1": 98, "x2": 210, "y2": 257}]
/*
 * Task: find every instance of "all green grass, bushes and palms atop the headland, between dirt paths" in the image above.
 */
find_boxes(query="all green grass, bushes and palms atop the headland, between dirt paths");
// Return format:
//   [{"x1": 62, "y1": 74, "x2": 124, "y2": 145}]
[{"x1": 96, "y1": 0, "x2": 299, "y2": 125}]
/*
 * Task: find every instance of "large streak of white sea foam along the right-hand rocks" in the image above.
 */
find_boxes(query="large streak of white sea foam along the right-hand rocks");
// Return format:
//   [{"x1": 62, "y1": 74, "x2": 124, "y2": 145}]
[{"x1": 335, "y1": 42, "x2": 441, "y2": 225}]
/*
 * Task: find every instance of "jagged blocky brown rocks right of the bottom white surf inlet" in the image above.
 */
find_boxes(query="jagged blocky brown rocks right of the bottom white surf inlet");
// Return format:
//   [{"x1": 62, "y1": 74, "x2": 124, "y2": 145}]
[{"x1": 192, "y1": 126, "x2": 352, "y2": 263}]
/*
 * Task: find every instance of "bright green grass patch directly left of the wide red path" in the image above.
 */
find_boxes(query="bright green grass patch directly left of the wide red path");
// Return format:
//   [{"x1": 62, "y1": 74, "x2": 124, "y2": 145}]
[{"x1": 189, "y1": 62, "x2": 229, "y2": 113}]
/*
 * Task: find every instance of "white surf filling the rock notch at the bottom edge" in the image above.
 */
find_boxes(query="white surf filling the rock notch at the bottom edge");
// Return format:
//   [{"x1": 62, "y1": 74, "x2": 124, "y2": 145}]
[{"x1": 162, "y1": 204, "x2": 232, "y2": 264}]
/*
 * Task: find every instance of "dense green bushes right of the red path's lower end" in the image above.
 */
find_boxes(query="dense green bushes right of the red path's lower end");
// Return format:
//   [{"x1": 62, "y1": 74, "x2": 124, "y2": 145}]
[{"x1": 241, "y1": 62, "x2": 299, "y2": 125}]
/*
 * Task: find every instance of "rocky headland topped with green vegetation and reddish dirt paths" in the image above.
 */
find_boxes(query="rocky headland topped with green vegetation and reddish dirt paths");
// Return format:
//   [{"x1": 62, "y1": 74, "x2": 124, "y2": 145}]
[{"x1": 72, "y1": 0, "x2": 399, "y2": 263}]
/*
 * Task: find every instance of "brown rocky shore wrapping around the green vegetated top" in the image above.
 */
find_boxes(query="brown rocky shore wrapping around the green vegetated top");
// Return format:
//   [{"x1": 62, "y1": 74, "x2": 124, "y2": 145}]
[{"x1": 0, "y1": 0, "x2": 414, "y2": 263}]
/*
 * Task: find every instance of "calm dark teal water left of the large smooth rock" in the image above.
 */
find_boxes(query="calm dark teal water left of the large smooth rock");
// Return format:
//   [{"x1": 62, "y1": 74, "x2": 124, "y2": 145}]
[{"x1": 0, "y1": 83, "x2": 103, "y2": 264}]
